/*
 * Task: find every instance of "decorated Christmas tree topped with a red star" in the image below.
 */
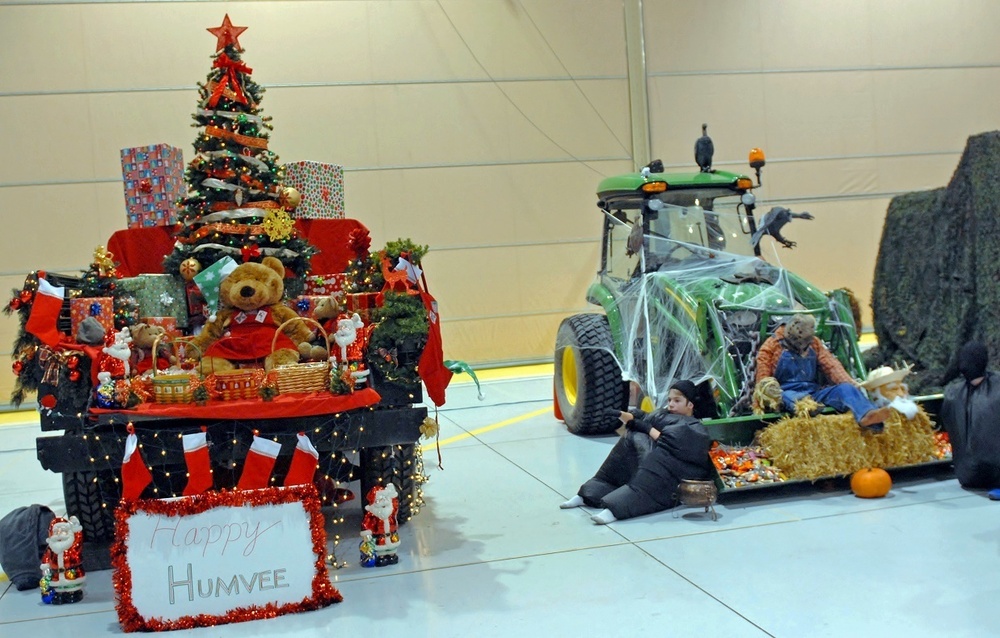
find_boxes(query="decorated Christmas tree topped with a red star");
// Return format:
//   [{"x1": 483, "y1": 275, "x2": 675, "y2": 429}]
[{"x1": 163, "y1": 14, "x2": 315, "y2": 296}]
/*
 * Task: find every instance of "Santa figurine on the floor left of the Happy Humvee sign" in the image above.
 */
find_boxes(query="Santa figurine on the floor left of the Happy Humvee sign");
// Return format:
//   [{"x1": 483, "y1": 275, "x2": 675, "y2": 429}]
[{"x1": 39, "y1": 516, "x2": 87, "y2": 605}]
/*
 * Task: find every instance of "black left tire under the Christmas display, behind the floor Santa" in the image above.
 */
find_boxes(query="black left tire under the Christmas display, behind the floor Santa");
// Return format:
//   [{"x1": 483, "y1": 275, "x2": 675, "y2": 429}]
[{"x1": 62, "y1": 471, "x2": 121, "y2": 543}]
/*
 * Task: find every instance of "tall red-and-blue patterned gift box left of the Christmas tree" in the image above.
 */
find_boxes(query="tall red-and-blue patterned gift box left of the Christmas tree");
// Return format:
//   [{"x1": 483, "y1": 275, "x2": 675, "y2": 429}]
[{"x1": 121, "y1": 144, "x2": 186, "y2": 228}]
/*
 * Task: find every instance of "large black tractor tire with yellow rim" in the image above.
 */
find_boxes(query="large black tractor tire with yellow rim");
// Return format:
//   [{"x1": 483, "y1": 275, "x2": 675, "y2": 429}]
[{"x1": 554, "y1": 314, "x2": 628, "y2": 434}]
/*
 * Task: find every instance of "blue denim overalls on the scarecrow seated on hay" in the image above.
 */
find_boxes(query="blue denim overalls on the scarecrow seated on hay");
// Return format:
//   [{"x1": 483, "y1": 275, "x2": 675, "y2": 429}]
[{"x1": 774, "y1": 348, "x2": 875, "y2": 422}]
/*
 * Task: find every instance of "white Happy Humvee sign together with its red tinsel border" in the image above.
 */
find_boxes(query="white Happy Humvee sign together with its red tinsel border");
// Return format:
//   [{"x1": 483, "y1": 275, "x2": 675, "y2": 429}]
[{"x1": 112, "y1": 485, "x2": 340, "y2": 631}]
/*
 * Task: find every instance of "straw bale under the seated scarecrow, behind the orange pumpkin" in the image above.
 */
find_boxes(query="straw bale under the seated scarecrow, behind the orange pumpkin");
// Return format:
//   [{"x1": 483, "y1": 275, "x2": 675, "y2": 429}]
[{"x1": 758, "y1": 408, "x2": 937, "y2": 480}]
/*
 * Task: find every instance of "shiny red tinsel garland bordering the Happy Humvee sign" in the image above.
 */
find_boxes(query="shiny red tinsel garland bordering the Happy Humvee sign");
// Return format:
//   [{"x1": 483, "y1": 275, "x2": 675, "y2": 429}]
[{"x1": 111, "y1": 484, "x2": 344, "y2": 632}]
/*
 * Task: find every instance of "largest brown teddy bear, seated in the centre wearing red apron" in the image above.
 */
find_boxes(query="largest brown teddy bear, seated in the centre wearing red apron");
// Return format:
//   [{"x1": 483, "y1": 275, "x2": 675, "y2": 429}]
[{"x1": 192, "y1": 257, "x2": 310, "y2": 374}]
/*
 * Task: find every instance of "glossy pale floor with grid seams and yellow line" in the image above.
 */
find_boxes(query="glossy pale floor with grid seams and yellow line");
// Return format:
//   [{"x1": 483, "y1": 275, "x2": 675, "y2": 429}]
[{"x1": 0, "y1": 368, "x2": 1000, "y2": 638}]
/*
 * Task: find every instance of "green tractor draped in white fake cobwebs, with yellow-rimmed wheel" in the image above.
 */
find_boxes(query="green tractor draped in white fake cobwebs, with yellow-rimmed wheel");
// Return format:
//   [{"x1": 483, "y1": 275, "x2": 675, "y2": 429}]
[{"x1": 554, "y1": 142, "x2": 866, "y2": 434}]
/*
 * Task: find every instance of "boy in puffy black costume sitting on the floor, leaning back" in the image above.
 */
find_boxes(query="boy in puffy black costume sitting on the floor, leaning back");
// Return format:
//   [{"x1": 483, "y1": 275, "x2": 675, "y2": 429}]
[{"x1": 559, "y1": 381, "x2": 712, "y2": 525}]
